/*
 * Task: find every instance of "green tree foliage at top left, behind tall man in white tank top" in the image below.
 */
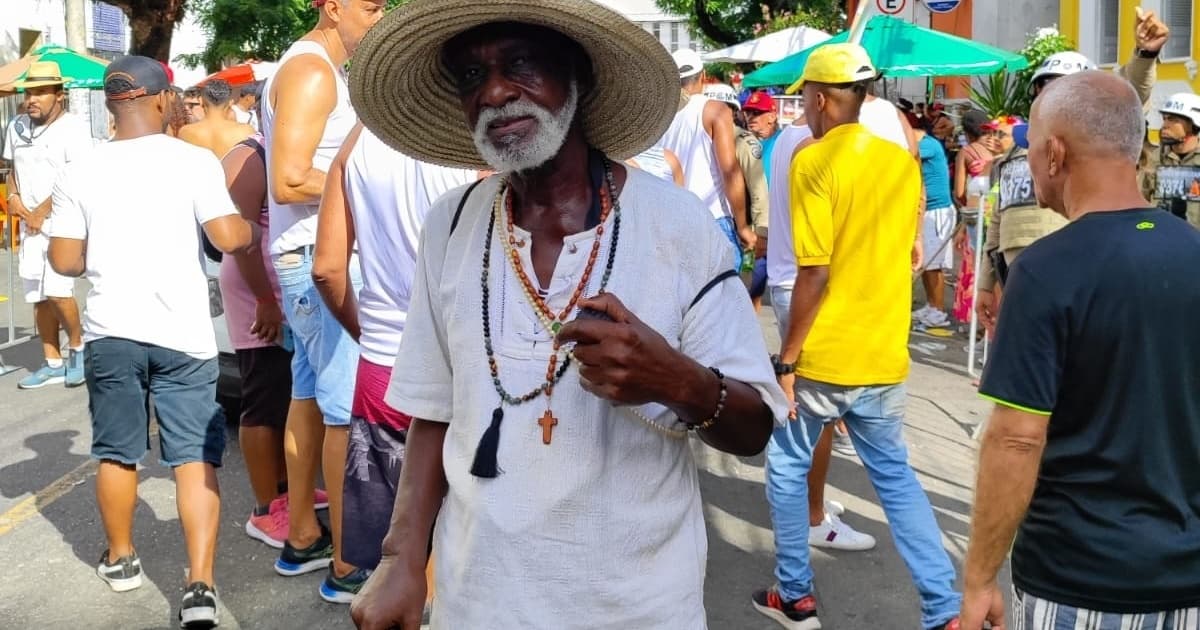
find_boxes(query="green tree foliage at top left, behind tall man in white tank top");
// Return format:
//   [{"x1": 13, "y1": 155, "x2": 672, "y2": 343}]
[{"x1": 175, "y1": 0, "x2": 408, "y2": 72}]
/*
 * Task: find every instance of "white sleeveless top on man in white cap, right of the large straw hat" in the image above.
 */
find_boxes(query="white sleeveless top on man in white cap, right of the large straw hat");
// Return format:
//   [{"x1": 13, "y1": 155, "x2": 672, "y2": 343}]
[{"x1": 659, "y1": 95, "x2": 731, "y2": 218}]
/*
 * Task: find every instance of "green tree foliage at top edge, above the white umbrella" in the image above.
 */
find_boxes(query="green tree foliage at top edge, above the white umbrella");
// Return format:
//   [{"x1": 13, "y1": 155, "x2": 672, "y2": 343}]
[{"x1": 655, "y1": 0, "x2": 846, "y2": 48}]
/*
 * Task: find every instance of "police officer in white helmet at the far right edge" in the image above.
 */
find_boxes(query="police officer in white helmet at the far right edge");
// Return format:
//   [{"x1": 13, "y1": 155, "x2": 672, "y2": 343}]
[{"x1": 1142, "y1": 92, "x2": 1200, "y2": 228}]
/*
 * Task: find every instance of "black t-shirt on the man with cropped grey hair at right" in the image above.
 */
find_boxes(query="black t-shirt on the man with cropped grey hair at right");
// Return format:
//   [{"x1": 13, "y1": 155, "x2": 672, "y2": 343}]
[{"x1": 979, "y1": 209, "x2": 1200, "y2": 613}]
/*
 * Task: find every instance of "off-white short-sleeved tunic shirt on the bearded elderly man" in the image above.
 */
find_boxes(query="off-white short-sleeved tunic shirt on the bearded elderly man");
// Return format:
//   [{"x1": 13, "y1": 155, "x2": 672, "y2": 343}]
[{"x1": 386, "y1": 169, "x2": 786, "y2": 630}]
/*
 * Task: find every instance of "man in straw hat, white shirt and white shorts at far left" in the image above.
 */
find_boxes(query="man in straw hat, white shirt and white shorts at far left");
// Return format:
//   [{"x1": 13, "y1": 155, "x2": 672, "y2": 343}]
[{"x1": 4, "y1": 61, "x2": 92, "y2": 389}]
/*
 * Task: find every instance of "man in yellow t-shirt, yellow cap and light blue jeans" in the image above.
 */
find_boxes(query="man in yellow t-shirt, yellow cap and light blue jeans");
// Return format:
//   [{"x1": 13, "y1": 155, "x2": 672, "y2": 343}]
[{"x1": 754, "y1": 43, "x2": 960, "y2": 630}]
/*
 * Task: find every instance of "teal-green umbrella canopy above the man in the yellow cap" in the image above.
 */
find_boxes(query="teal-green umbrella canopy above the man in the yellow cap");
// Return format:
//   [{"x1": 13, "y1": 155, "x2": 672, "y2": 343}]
[{"x1": 742, "y1": 16, "x2": 1030, "y2": 88}]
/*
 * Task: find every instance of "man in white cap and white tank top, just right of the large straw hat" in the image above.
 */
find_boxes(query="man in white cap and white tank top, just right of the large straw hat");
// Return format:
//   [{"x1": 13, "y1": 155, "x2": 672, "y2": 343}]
[{"x1": 661, "y1": 48, "x2": 756, "y2": 269}]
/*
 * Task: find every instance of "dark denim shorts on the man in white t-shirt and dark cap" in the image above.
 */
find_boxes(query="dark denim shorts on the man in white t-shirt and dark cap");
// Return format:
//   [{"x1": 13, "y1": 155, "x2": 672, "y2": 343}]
[{"x1": 84, "y1": 337, "x2": 226, "y2": 467}]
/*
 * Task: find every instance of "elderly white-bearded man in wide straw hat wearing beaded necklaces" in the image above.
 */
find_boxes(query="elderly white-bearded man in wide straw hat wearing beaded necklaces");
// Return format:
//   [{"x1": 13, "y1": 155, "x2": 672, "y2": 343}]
[{"x1": 350, "y1": 0, "x2": 786, "y2": 630}]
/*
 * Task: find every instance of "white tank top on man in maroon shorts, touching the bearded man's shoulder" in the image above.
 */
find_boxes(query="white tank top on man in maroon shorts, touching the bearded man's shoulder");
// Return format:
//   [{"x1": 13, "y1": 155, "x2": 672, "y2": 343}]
[{"x1": 345, "y1": 128, "x2": 476, "y2": 367}]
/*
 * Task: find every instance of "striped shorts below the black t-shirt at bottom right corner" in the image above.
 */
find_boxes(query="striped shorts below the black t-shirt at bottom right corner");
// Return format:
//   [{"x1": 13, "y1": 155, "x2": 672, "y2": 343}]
[{"x1": 1012, "y1": 588, "x2": 1200, "y2": 630}]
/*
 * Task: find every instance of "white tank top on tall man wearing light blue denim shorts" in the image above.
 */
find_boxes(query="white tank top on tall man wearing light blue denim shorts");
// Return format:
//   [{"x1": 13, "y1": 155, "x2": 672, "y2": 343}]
[{"x1": 262, "y1": 40, "x2": 358, "y2": 256}]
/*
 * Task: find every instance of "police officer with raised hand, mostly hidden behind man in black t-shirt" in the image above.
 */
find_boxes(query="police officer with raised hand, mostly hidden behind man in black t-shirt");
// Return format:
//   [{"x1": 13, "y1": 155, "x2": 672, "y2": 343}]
[{"x1": 974, "y1": 24, "x2": 1168, "y2": 330}]
